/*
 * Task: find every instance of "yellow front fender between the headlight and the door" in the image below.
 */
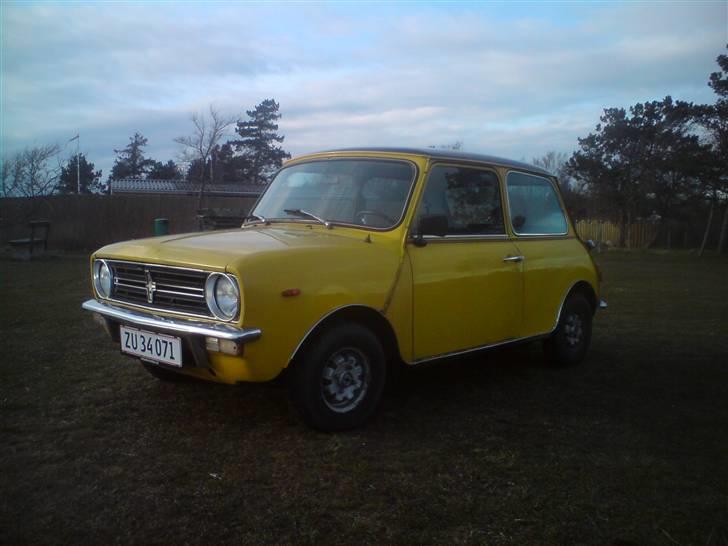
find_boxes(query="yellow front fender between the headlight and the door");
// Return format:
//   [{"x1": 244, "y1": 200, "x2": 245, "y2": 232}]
[{"x1": 228, "y1": 241, "x2": 400, "y2": 379}]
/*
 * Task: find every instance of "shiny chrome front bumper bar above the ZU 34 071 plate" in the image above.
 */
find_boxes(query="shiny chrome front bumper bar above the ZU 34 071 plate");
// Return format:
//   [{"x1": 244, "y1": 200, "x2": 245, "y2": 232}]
[{"x1": 81, "y1": 300, "x2": 262, "y2": 343}]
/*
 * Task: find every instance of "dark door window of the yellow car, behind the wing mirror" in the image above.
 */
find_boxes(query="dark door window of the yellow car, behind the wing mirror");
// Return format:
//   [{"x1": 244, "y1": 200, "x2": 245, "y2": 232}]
[{"x1": 418, "y1": 165, "x2": 505, "y2": 235}]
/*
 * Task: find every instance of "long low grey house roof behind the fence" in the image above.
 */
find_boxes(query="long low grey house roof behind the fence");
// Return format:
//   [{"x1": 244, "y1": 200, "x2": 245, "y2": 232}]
[{"x1": 110, "y1": 178, "x2": 265, "y2": 197}]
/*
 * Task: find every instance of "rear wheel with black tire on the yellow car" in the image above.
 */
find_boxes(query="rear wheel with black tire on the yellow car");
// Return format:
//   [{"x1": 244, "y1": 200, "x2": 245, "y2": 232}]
[{"x1": 543, "y1": 293, "x2": 593, "y2": 366}]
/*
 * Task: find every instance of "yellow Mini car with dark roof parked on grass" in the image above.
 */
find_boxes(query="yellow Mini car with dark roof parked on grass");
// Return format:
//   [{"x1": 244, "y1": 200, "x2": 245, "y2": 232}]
[{"x1": 83, "y1": 149, "x2": 606, "y2": 430}]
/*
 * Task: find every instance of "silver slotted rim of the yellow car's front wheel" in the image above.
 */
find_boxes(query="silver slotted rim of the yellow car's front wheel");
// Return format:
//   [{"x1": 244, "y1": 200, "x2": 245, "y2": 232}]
[{"x1": 321, "y1": 347, "x2": 371, "y2": 413}]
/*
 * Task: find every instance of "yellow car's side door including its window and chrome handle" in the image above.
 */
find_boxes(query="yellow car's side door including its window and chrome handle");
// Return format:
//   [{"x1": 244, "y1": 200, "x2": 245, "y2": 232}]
[{"x1": 407, "y1": 164, "x2": 523, "y2": 361}]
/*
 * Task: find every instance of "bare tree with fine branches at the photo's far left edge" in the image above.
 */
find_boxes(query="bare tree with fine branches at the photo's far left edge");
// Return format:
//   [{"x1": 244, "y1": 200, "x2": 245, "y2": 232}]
[{"x1": 0, "y1": 144, "x2": 61, "y2": 197}]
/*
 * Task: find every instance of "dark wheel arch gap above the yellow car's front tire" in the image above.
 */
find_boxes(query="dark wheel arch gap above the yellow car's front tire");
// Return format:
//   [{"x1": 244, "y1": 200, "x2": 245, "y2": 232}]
[{"x1": 287, "y1": 304, "x2": 401, "y2": 367}]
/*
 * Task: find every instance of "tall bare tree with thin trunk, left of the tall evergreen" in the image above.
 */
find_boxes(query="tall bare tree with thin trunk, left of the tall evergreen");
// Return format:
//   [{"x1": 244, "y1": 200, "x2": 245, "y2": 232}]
[{"x1": 174, "y1": 104, "x2": 237, "y2": 207}]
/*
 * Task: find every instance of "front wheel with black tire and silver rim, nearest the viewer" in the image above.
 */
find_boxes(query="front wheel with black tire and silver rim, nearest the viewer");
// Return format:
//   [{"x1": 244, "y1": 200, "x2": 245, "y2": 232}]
[{"x1": 289, "y1": 323, "x2": 387, "y2": 432}]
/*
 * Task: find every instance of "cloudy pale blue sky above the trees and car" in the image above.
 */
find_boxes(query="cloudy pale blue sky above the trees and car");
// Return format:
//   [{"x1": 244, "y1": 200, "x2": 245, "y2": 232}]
[{"x1": 0, "y1": 0, "x2": 728, "y2": 178}]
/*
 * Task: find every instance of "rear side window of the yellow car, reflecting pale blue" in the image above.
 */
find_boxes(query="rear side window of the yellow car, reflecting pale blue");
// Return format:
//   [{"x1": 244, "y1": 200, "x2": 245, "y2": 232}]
[{"x1": 506, "y1": 172, "x2": 568, "y2": 235}]
